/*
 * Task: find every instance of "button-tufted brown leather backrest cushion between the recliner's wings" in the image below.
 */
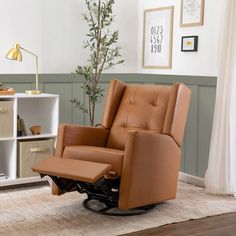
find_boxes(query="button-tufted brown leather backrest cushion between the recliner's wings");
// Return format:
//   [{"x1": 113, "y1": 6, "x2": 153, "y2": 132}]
[{"x1": 107, "y1": 85, "x2": 171, "y2": 150}]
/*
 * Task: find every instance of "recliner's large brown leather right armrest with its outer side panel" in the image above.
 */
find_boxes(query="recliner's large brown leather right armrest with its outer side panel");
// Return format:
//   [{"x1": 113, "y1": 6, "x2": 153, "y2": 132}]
[{"x1": 119, "y1": 131, "x2": 181, "y2": 209}]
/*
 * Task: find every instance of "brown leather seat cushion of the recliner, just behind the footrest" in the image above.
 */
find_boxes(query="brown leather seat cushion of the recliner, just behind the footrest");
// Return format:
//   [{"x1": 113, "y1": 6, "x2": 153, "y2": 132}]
[{"x1": 63, "y1": 146, "x2": 124, "y2": 176}]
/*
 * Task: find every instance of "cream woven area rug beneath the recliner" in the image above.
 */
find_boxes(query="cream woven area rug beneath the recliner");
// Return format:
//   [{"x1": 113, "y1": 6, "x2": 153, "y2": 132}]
[{"x1": 0, "y1": 182, "x2": 236, "y2": 236}]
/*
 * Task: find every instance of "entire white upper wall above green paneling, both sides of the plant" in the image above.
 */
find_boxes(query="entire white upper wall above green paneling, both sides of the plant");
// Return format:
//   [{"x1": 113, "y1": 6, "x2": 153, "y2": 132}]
[{"x1": 0, "y1": 0, "x2": 223, "y2": 76}]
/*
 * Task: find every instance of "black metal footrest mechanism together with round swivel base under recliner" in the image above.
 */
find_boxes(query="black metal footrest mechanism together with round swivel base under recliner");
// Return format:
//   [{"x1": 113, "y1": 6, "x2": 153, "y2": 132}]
[{"x1": 48, "y1": 175, "x2": 155, "y2": 216}]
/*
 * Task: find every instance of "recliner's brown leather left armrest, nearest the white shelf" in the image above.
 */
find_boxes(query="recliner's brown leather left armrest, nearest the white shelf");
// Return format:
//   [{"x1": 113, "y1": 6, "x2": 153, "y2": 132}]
[{"x1": 55, "y1": 124, "x2": 109, "y2": 157}]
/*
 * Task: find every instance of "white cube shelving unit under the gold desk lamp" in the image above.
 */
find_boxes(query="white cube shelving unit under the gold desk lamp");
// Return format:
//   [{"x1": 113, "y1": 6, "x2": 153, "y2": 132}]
[{"x1": 0, "y1": 93, "x2": 59, "y2": 186}]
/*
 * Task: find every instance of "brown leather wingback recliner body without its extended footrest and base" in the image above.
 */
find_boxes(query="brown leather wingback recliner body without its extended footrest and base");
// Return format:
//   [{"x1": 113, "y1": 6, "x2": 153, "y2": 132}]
[{"x1": 53, "y1": 80, "x2": 191, "y2": 209}]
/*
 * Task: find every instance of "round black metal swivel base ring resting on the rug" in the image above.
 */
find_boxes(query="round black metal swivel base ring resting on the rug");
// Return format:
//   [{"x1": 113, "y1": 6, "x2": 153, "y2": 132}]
[{"x1": 83, "y1": 198, "x2": 155, "y2": 216}]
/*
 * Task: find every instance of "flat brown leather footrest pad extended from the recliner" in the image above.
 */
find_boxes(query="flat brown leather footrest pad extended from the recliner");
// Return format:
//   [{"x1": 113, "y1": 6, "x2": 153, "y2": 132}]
[{"x1": 32, "y1": 157, "x2": 112, "y2": 183}]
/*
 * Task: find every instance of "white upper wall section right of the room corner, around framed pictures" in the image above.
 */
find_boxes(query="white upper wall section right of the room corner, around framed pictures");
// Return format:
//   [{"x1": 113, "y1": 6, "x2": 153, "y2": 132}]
[{"x1": 138, "y1": 0, "x2": 223, "y2": 76}]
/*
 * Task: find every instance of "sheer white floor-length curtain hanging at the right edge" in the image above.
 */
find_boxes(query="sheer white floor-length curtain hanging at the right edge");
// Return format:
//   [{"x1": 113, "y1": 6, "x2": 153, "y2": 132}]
[{"x1": 205, "y1": 0, "x2": 236, "y2": 195}]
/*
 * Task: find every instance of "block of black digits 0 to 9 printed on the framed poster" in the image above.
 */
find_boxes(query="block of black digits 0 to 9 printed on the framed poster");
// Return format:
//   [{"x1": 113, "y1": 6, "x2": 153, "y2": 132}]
[{"x1": 150, "y1": 25, "x2": 163, "y2": 53}]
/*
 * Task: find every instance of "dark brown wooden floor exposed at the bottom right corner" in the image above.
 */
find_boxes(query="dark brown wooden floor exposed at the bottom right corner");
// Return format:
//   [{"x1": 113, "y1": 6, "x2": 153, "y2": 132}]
[{"x1": 122, "y1": 213, "x2": 236, "y2": 236}]
